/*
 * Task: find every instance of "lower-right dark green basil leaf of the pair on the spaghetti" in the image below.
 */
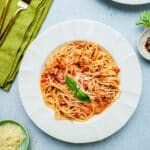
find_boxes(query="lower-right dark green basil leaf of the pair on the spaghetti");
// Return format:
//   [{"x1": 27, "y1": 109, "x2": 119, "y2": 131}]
[{"x1": 75, "y1": 89, "x2": 90, "y2": 102}]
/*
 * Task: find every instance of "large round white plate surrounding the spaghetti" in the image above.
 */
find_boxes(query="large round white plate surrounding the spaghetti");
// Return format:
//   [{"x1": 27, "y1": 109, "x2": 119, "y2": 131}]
[{"x1": 19, "y1": 20, "x2": 142, "y2": 143}]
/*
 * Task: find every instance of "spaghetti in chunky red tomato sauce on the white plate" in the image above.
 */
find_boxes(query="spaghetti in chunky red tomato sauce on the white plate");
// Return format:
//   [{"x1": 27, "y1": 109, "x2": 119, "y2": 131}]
[{"x1": 40, "y1": 41, "x2": 120, "y2": 121}]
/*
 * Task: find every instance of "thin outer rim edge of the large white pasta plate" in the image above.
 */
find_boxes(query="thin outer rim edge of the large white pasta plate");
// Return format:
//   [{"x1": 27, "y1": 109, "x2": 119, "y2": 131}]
[{"x1": 18, "y1": 19, "x2": 142, "y2": 143}]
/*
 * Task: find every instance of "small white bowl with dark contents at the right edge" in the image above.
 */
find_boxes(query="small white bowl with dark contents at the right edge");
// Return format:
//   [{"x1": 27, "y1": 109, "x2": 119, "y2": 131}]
[{"x1": 137, "y1": 28, "x2": 150, "y2": 61}]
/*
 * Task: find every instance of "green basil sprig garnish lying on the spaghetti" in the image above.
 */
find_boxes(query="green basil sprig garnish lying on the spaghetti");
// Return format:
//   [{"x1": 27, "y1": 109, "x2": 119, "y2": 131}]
[{"x1": 65, "y1": 75, "x2": 90, "y2": 102}]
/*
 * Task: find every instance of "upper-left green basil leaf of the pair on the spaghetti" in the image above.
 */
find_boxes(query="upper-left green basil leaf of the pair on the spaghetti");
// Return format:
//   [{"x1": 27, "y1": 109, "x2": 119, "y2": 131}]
[{"x1": 65, "y1": 75, "x2": 77, "y2": 92}]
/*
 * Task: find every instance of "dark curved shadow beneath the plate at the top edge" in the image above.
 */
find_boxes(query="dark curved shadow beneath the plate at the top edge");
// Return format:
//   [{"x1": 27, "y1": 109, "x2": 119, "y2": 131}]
[{"x1": 95, "y1": 0, "x2": 150, "y2": 12}]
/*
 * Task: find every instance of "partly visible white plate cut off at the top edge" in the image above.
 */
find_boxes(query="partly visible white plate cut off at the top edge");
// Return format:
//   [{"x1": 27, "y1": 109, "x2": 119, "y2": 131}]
[{"x1": 112, "y1": 0, "x2": 150, "y2": 5}]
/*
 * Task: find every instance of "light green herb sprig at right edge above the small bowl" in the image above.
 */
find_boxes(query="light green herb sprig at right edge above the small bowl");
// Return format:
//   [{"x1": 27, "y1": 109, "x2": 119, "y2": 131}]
[{"x1": 136, "y1": 11, "x2": 150, "y2": 27}]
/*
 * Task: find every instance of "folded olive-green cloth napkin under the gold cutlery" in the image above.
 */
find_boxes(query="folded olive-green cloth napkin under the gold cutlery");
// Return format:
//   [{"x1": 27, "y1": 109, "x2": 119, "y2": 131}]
[{"x1": 0, "y1": 0, "x2": 52, "y2": 91}]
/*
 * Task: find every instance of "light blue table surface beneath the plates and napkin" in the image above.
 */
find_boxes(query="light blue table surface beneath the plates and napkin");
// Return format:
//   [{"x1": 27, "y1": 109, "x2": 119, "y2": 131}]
[{"x1": 0, "y1": 0, "x2": 150, "y2": 150}]
